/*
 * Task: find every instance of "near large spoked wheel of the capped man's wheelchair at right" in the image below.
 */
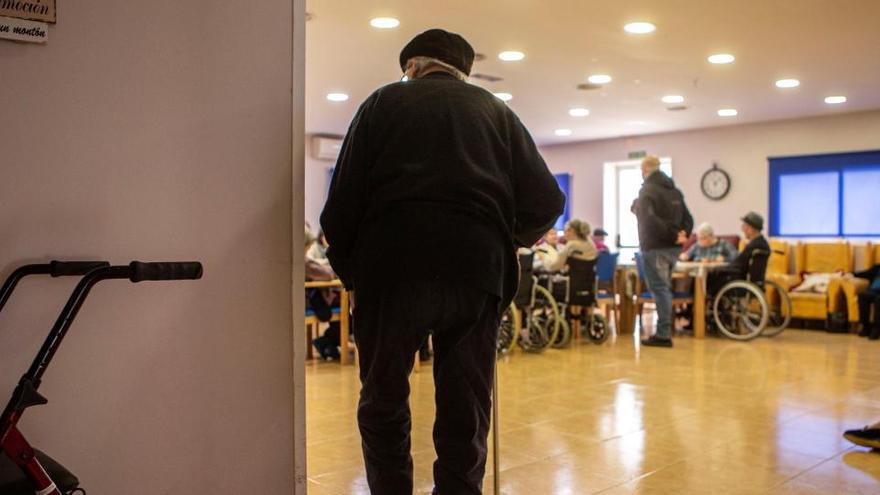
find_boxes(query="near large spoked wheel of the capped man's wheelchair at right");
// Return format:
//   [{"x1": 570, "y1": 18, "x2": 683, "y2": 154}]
[{"x1": 713, "y1": 280, "x2": 770, "y2": 340}]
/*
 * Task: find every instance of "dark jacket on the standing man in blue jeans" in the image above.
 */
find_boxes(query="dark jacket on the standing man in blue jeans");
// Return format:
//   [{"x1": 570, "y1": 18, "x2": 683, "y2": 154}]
[{"x1": 633, "y1": 171, "x2": 694, "y2": 251}]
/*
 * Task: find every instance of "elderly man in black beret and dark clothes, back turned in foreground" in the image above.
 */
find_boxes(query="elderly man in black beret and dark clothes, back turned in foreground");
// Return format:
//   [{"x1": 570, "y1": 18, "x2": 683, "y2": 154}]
[{"x1": 321, "y1": 29, "x2": 565, "y2": 495}]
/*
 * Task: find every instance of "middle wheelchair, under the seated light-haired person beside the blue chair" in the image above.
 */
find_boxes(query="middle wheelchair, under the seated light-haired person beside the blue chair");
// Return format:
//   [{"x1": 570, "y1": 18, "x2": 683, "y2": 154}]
[{"x1": 548, "y1": 258, "x2": 610, "y2": 348}]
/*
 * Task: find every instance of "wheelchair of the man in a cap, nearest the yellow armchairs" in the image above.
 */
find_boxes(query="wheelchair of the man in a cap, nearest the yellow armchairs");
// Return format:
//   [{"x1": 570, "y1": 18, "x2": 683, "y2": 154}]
[{"x1": 707, "y1": 250, "x2": 791, "y2": 341}]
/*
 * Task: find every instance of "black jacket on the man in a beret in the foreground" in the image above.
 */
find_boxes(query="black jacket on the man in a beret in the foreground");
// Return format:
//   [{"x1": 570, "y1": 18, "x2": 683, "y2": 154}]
[{"x1": 321, "y1": 73, "x2": 565, "y2": 308}]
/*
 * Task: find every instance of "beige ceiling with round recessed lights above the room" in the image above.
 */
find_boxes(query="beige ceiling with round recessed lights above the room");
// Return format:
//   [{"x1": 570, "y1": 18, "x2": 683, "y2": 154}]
[{"x1": 306, "y1": 0, "x2": 880, "y2": 145}]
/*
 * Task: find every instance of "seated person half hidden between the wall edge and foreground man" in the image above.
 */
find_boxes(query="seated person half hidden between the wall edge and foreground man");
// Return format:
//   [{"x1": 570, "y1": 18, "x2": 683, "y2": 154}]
[{"x1": 305, "y1": 229, "x2": 340, "y2": 361}]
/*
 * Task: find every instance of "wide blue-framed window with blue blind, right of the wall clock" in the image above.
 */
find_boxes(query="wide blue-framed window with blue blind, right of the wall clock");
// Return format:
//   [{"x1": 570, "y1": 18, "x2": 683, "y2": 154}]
[{"x1": 769, "y1": 151, "x2": 880, "y2": 237}]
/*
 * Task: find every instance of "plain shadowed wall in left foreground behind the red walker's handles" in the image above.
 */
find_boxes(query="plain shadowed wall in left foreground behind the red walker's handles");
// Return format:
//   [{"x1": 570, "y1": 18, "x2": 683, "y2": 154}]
[{"x1": 0, "y1": 0, "x2": 302, "y2": 495}]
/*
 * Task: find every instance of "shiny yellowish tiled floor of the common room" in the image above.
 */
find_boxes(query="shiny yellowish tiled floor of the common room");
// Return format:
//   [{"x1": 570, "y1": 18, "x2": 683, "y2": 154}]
[{"x1": 307, "y1": 330, "x2": 880, "y2": 495}]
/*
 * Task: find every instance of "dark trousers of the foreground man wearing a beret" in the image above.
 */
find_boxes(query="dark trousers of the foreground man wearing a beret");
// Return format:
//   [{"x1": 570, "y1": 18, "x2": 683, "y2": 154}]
[{"x1": 354, "y1": 282, "x2": 499, "y2": 495}]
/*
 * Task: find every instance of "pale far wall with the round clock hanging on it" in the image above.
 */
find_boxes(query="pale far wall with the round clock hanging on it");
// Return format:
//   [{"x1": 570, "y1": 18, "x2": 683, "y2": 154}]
[{"x1": 541, "y1": 111, "x2": 880, "y2": 238}]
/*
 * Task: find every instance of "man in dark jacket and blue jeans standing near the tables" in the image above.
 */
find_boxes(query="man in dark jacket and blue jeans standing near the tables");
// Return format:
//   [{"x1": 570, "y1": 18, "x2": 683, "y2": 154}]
[{"x1": 633, "y1": 156, "x2": 694, "y2": 347}]
